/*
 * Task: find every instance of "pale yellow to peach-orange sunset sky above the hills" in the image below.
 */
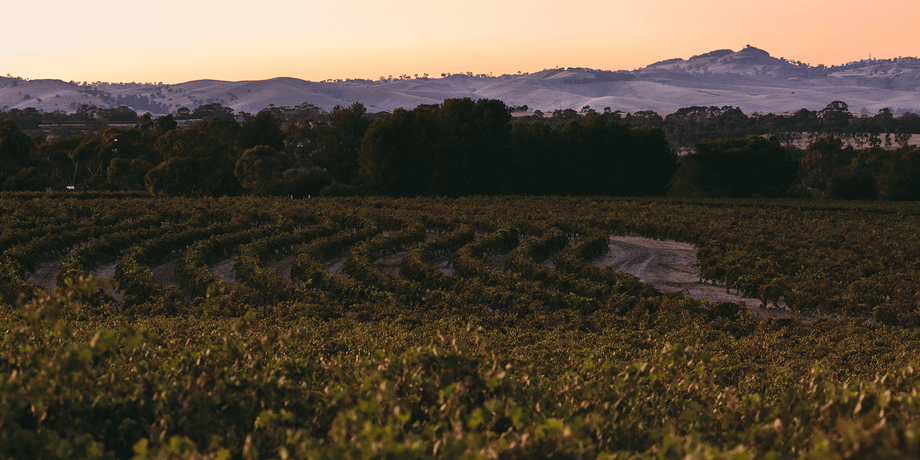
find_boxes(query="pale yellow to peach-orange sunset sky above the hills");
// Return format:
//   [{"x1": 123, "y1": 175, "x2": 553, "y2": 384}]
[{"x1": 7, "y1": 0, "x2": 920, "y2": 83}]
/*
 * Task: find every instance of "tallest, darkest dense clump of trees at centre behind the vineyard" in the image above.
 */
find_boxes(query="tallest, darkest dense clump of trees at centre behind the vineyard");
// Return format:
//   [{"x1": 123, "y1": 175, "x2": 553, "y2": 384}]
[{"x1": 361, "y1": 99, "x2": 676, "y2": 195}]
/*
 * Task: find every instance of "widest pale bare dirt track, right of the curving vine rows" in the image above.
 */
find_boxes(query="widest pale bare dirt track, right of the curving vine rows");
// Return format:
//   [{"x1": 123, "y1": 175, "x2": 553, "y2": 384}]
[{"x1": 591, "y1": 236, "x2": 793, "y2": 317}]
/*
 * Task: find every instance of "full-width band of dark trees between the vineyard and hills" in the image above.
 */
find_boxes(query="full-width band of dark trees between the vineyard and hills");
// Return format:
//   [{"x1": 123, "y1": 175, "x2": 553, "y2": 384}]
[{"x1": 0, "y1": 98, "x2": 920, "y2": 200}]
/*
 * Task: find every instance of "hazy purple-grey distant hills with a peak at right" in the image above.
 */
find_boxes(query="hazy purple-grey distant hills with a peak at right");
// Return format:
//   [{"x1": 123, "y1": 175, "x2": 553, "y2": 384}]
[{"x1": 0, "y1": 46, "x2": 920, "y2": 115}]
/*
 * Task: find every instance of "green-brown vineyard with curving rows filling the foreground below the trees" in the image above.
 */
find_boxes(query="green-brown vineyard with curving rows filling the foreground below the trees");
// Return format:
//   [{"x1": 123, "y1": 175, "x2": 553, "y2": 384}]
[{"x1": 0, "y1": 192, "x2": 920, "y2": 458}]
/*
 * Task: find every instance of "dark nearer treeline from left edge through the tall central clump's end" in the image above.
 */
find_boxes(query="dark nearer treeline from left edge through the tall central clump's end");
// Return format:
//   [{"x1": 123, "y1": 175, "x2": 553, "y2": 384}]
[{"x1": 0, "y1": 98, "x2": 677, "y2": 196}]
